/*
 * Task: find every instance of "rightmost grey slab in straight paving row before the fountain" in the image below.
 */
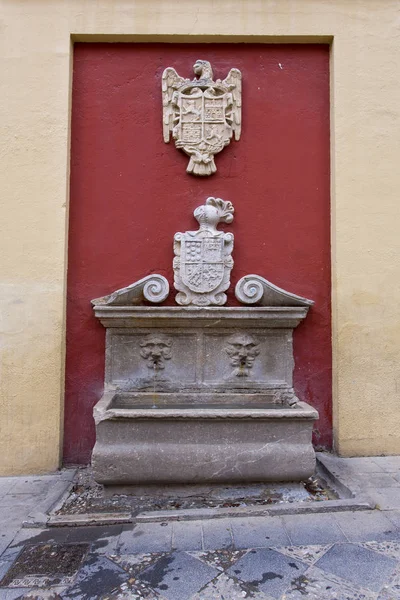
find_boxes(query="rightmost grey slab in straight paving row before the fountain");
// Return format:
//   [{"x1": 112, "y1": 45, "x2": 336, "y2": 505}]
[{"x1": 334, "y1": 510, "x2": 400, "y2": 542}]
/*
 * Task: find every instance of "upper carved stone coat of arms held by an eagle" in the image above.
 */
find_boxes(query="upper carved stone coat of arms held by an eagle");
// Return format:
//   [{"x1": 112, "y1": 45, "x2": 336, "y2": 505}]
[{"x1": 162, "y1": 60, "x2": 242, "y2": 175}]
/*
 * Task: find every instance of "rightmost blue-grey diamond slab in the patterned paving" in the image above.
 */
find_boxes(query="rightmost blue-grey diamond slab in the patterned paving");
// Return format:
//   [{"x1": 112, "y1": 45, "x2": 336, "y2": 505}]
[{"x1": 315, "y1": 544, "x2": 398, "y2": 592}]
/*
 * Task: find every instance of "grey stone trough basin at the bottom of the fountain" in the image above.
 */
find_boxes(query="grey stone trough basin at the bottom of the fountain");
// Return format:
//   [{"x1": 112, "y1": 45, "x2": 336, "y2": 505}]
[{"x1": 92, "y1": 391, "x2": 318, "y2": 486}]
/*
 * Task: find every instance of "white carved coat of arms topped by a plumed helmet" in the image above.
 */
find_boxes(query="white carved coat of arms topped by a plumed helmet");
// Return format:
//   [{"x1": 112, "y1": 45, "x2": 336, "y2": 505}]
[{"x1": 174, "y1": 198, "x2": 234, "y2": 306}]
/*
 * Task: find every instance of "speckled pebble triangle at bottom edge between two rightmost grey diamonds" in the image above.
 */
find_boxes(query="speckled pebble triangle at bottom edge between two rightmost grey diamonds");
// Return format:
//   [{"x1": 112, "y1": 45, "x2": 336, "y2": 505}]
[{"x1": 284, "y1": 567, "x2": 376, "y2": 600}]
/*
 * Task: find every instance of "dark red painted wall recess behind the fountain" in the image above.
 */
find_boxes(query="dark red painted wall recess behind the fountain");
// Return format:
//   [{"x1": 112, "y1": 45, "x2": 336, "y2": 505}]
[{"x1": 64, "y1": 44, "x2": 331, "y2": 463}]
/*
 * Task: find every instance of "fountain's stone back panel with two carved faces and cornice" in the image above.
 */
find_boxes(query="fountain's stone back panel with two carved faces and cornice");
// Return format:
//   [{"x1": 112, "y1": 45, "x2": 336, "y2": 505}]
[{"x1": 95, "y1": 305, "x2": 308, "y2": 392}]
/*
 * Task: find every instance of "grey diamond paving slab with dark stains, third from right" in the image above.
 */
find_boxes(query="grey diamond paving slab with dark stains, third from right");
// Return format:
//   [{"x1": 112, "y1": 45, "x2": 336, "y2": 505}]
[{"x1": 139, "y1": 552, "x2": 219, "y2": 600}]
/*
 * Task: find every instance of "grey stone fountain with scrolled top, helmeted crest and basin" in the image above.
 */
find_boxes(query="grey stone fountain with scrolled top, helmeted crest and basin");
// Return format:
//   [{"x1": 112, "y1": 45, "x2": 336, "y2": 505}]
[{"x1": 92, "y1": 198, "x2": 318, "y2": 486}]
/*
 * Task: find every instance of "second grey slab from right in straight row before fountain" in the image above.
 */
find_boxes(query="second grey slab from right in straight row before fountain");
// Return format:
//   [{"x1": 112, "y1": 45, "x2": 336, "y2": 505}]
[{"x1": 282, "y1": 514, "x2": 347, "y2": 546}]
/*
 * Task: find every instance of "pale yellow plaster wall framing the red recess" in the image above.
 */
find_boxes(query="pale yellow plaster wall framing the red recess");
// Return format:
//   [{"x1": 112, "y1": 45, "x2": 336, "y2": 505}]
[{"x1": 0, "y1": 0, "x2": 400, "y2": 474}]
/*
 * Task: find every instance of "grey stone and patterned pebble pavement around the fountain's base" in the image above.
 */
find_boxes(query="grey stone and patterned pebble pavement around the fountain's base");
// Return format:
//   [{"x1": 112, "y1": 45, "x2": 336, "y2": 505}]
[{"x1": 0, "y1": 457, "x2": 400, "y2": 600}]
